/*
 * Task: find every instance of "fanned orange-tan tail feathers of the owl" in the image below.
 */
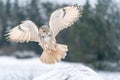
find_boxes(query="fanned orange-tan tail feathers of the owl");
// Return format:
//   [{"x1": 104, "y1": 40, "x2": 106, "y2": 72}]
[{"x1": 40, "y1": 44, "x2": 68, "y2": 64}]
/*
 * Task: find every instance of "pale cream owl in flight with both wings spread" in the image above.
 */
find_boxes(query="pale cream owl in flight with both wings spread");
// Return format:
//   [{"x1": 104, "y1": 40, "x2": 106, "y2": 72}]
[{"x1": 7, "y1": 5, "x2": 82, "y2": 64}]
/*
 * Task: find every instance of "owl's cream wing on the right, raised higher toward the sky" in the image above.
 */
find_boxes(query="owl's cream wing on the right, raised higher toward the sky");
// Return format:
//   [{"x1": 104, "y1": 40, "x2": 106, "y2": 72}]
[{"x1": 49, "y1": 5, "x2": 82, "y2": 36}]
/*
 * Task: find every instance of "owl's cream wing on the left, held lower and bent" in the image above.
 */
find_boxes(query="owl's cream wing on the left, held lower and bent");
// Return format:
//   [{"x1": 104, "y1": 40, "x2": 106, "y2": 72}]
[{"x1": 7, "y1": 20, "x2": 38, "y2": 42}]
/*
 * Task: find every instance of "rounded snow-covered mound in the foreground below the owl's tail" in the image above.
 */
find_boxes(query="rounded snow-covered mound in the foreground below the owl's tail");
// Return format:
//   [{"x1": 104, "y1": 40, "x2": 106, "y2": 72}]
[{"x1": 33, "y1": 63, "x2": 102, "y2": 80}]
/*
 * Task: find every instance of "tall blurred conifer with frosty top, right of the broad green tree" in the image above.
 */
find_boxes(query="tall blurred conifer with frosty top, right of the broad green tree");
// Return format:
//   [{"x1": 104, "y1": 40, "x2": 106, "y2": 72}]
[{"x1": 95, "y1": 0, "x2": 118, "y2": 60}]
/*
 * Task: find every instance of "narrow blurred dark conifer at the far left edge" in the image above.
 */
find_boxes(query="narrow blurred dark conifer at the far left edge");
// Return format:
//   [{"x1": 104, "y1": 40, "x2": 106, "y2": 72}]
[{"x1": 0, "y1": 0, "x2": 11, "y2": 47}]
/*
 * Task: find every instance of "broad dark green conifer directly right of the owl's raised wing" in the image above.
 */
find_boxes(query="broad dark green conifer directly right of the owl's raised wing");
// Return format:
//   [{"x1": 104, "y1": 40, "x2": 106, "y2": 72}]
[{"x1": 66, "y1": 0, "x2": 94, "y2": 61}]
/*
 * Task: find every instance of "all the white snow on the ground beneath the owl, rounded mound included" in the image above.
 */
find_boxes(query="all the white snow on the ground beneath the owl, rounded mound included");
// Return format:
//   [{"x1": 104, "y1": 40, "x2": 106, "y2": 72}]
[{"x1": 0, "y1": 57, "x2": 120, "y2": 80}]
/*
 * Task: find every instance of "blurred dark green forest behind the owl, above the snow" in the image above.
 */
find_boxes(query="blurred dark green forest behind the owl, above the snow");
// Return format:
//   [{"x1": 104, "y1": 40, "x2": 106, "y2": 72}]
[{"x1": 0, "y1": 0, "x2": 120, "y2": 71}]
